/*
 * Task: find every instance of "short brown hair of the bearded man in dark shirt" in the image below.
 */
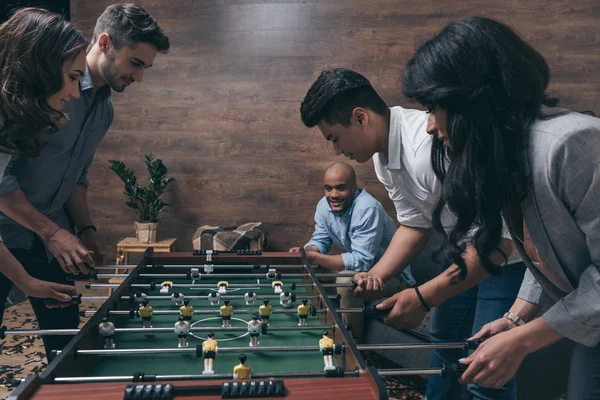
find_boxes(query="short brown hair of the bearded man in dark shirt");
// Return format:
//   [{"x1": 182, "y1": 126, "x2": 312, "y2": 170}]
[{"x1": 92, "y1": 3, "x2": 171, "y2": 54}]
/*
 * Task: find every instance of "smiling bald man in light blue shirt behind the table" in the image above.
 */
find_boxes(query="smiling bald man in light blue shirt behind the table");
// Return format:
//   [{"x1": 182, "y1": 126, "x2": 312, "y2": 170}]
[{"x1": 290, "y1": 163, "x2": 415, "y2": 342}]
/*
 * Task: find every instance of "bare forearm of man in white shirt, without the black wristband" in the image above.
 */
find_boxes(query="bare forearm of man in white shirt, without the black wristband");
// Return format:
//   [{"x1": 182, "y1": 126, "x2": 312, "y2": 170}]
[{"x1": 369, "y1": 225, "x2": 431, "y2": 282}]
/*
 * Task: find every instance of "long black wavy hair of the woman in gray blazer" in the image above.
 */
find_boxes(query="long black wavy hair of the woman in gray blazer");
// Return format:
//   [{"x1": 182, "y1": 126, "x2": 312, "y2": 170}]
[{"x1": 403, "y1": 17, "x2": 557, "y2": 279}]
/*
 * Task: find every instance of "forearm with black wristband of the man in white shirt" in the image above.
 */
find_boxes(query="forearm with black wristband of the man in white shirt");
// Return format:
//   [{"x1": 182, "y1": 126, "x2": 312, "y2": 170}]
[{"x1": 419, "y1": 240, "x2": 512, "y2": 307}]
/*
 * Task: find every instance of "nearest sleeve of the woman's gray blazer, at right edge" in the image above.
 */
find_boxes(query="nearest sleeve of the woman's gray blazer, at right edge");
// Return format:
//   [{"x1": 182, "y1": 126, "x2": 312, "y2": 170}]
[{"x1": 543, "y1": 130, "x2": 600, "y2": 346}]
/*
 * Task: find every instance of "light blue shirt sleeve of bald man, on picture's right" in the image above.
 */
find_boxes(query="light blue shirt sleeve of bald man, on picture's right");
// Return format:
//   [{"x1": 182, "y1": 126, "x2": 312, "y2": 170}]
[{"x1": 342, "y1": 207, "x2": 383, "y2": 272}]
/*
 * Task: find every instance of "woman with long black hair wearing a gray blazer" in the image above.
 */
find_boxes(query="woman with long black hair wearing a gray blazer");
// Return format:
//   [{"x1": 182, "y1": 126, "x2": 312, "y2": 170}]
[{"x1": 403, "y1": 17, "x2": 600, "y2": 399}]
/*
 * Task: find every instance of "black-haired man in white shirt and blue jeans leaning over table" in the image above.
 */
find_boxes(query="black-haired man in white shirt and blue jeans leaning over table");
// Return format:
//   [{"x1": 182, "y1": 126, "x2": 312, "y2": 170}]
[{"x1": 300, "y1": 68, "x2": 525, "y2": 400}]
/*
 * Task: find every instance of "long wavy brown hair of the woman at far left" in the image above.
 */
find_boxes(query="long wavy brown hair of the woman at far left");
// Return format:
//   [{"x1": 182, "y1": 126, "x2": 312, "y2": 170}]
[{"x1": 0, "y1": 8, "x2": 87, "y2": 157}]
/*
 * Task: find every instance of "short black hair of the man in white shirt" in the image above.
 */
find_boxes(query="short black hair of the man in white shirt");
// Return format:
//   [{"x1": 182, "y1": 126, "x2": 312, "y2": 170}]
[{"x1": 300, "y1": 68, "x2": 388, "y2": 128}]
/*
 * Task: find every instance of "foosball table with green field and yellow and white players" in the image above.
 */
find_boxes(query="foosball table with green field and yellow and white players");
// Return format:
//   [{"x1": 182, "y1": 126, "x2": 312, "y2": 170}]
[{"x1": 2, "y1": 249, "x2": 477, "y2": 400}]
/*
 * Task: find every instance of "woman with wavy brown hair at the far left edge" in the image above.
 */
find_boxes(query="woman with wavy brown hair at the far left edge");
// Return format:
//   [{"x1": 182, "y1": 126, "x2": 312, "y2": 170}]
[{"x1": 0, "y1": 8, "x2": 88, "y2": 301}]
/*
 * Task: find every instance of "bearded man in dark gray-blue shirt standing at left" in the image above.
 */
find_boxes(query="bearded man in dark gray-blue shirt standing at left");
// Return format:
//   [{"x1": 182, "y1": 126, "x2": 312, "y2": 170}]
[{"x1": 0, "y1": 4, "x2": 170, "y2": 355}]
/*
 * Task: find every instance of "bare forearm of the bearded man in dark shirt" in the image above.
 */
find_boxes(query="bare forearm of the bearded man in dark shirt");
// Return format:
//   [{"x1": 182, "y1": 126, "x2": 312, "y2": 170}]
[{"x1": 0, "y1": 189, "x2": 59, "y2": 241}]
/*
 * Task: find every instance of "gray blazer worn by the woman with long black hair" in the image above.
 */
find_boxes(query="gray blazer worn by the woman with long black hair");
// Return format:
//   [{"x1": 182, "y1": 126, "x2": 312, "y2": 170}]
[{"x1": 515, "y1": 107, "x2": 600, "y2": 346}]
